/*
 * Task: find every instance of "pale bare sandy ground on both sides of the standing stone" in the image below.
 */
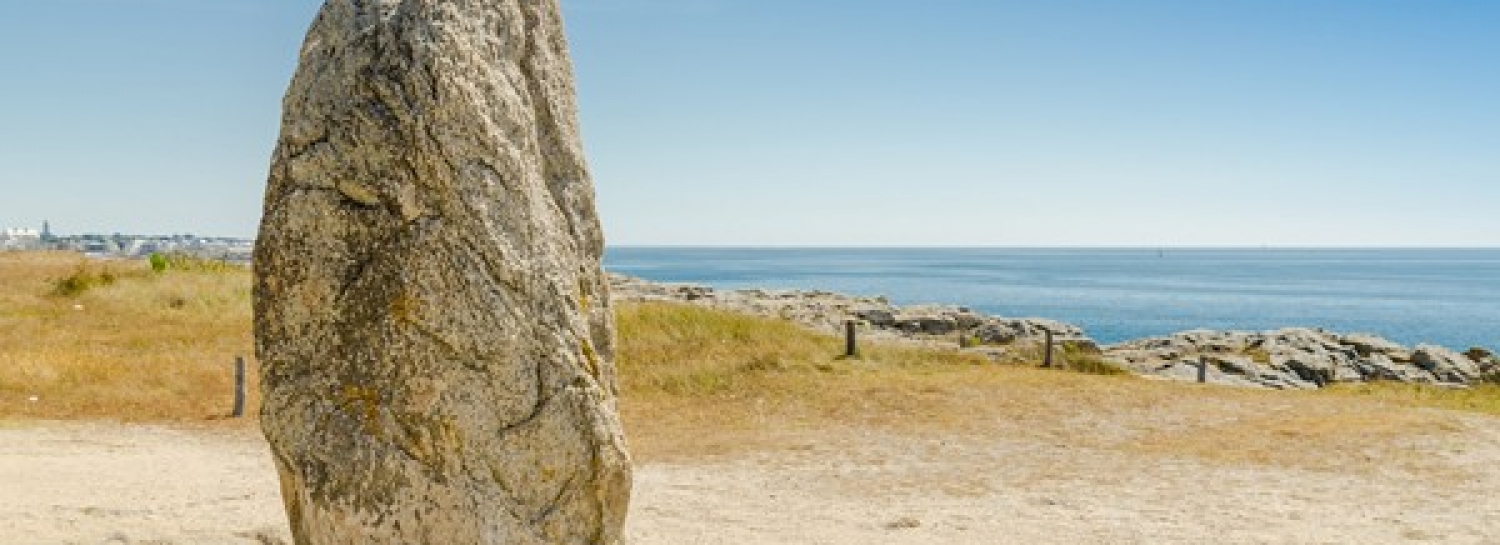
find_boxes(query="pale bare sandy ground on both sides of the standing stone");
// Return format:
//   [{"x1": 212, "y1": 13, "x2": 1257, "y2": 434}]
[{"x1": 0, "y1": 416, "x2": 1500, "y2": 545}]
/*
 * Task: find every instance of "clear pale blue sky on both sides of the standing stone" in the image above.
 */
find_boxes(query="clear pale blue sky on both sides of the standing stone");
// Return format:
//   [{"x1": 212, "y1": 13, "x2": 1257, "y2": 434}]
[{"x1": 0, "y1": 0, "x2": 1500, "y2": 246}]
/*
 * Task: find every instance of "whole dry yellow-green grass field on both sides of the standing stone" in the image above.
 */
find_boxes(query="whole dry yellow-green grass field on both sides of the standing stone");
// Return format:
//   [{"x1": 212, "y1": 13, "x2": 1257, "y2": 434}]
[{"x1": 0, "y1": 254, "x2": 1500, "y2": 462}]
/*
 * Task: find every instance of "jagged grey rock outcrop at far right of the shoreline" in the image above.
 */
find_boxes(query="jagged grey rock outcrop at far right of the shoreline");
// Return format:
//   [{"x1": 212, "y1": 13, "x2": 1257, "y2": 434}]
[{"x1": 1104, "y1": 329, "x2": 1500, "y2": 389}]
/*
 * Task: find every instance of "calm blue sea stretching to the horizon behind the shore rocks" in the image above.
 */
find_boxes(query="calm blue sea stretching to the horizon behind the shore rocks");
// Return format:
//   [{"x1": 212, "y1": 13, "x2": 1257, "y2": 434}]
[{"x1": 605, "y1": 248, "x2": 1500, "y2": 350}]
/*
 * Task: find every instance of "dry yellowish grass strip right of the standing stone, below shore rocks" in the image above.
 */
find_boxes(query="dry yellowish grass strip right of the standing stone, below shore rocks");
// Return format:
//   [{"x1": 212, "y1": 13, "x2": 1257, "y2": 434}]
[{"x1": 620, "y1": 303, "x2": 1476, "y2": 471}]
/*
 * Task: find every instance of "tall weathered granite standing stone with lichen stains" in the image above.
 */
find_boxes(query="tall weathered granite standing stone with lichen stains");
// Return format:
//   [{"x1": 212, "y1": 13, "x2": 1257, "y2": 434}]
[{"x1": 255, "y1": 0, "x2": 630, "y2": 545}]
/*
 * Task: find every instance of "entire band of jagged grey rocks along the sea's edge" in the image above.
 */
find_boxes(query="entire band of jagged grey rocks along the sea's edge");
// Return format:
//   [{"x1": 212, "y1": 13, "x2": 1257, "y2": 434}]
[{"x1": 609, "y1": 273, "x2": 1500, "y2": 389}]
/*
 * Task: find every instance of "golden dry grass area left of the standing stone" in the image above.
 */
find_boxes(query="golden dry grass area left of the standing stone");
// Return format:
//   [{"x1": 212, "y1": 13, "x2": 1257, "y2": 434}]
[{"x1": 0, "y1": 252, "x2": 254, "y2": 420}]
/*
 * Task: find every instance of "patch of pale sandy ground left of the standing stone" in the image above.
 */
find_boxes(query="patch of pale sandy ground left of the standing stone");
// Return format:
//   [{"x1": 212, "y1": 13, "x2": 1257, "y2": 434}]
[{"x1": 0, "y1": 423, "x2": 285, "y2": 545}]
